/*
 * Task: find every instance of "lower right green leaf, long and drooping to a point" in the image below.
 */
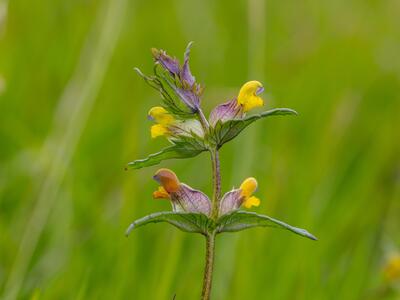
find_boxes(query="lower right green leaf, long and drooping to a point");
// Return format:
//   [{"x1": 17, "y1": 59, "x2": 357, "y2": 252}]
[{"x1": 216, "y1": 210, "x2": 317, "y2": 240}]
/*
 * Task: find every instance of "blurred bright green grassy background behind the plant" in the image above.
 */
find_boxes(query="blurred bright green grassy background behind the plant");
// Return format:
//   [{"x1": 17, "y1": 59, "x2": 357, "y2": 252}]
[{"x1": 0, "y1": 0, "x2": 400, "y2": 300}]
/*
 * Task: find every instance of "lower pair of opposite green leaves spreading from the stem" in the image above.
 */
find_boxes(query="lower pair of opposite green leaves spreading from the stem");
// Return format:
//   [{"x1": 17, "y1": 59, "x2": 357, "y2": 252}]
[{"x1": 126, "y1": 210, "x2": 317, "y2": 240}]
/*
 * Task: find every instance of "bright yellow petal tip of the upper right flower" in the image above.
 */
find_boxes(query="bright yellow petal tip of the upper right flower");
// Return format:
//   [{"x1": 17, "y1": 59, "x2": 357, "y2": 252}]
[{"x1": 237, "y1": 80, "x2": 264, "y2": 112}]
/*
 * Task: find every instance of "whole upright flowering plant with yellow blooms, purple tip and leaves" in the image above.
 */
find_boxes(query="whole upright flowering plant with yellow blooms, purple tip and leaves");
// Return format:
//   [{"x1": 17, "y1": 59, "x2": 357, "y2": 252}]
[{"x1": 126, "y1": 43, "x2": 316, "y2": 300}]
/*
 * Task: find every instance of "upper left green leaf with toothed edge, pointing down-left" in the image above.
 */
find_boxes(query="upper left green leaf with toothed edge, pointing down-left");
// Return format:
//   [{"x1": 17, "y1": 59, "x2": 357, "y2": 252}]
[{"x1": 127, "y1": 134, "x2": 207, "y2": 169}]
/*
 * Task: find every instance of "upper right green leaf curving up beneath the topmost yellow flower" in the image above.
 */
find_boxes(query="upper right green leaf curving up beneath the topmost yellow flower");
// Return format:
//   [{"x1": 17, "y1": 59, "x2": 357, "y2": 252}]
[{"x1": 209, "y1": 108, "x2": 297, "y2": 148}]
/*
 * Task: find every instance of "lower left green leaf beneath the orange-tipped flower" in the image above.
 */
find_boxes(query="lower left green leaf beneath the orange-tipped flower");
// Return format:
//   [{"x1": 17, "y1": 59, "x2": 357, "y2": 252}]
[{"x1": 125, "y1": 211, "x2": 212, "y2": 236}]
